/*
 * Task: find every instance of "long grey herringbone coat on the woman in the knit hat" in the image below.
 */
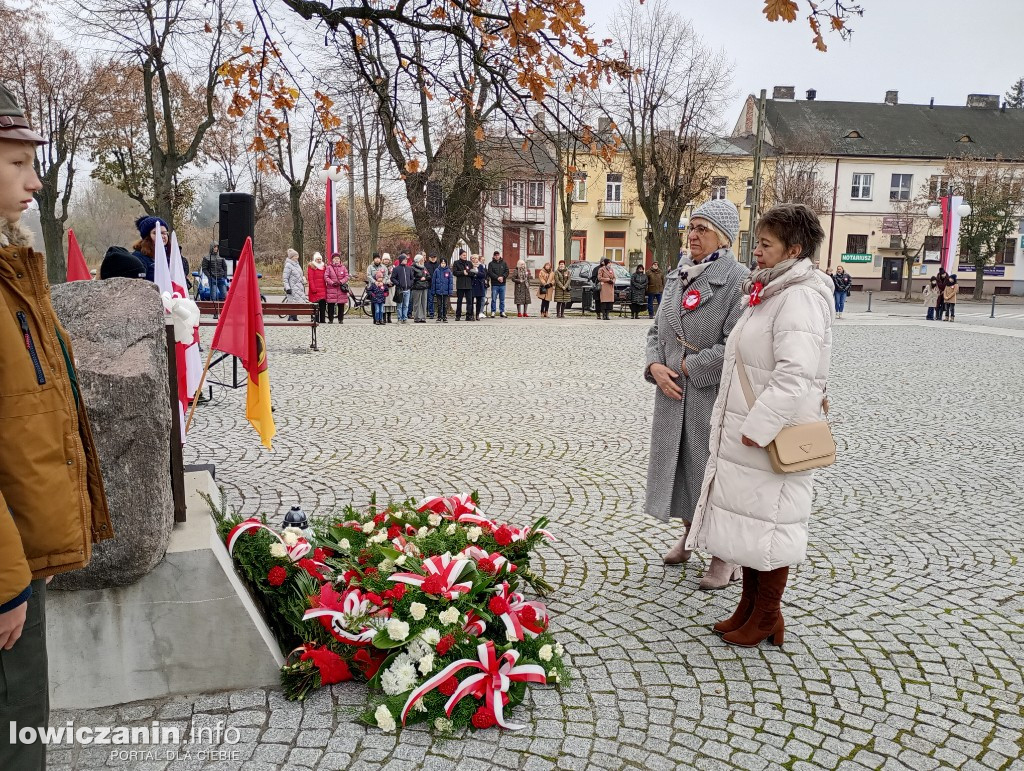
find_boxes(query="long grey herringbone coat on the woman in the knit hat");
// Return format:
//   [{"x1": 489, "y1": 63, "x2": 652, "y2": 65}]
[{"x1": 644, "y1": 251, "x2": 750, "y2": 521}]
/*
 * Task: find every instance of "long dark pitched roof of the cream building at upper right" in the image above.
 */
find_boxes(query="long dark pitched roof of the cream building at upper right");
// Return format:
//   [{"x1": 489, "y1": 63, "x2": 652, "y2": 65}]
[{"x1": 766, "y1": 99, "x2": 1024, "y2": 160}]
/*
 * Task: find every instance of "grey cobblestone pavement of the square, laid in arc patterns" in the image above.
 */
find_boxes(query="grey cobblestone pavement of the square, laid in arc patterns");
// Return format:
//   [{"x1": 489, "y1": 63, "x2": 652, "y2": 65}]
[{"x1": 58, "y1": 318, "x2": 1024, "y2": 771}]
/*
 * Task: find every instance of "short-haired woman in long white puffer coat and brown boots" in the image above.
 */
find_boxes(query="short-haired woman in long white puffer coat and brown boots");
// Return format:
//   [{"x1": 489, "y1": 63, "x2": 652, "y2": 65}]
[{"x1": 686, "y1": 204, "x2": 834, "y2": 647}]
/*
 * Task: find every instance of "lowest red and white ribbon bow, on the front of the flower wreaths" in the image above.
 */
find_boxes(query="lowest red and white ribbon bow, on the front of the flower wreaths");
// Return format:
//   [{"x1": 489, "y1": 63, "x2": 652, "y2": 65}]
[{"x1": 401, "y1": 640, "x2": 548, "y2": 731}]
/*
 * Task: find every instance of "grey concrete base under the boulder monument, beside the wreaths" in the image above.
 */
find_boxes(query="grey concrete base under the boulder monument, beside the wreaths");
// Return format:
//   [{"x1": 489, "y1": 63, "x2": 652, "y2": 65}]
[{"x1": 46, "y1": 470, "x2": 283, "y2": 710}]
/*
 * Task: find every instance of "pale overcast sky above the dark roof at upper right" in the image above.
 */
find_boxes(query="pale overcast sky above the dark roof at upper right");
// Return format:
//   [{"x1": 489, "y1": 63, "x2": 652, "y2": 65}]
[{"x1": 584, "y1": 0, "x2": 1024, "y2": 124}]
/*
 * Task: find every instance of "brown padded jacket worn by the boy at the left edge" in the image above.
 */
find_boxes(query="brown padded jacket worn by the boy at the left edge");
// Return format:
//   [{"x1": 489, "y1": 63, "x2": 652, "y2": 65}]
[{"x1": 0, "y1": 221, "x2": 114, "y2": 604}]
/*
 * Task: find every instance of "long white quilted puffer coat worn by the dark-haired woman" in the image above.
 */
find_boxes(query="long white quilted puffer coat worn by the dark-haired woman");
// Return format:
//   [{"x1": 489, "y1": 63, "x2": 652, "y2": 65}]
[{"x1": 686, "y1": 260, "x2": 834, "y2": 570}]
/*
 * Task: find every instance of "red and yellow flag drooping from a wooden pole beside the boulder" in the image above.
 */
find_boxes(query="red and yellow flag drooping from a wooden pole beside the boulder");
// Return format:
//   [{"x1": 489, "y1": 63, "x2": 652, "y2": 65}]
[{"x1": 210, "y1": 239, "x2": 278, "y2": 449}]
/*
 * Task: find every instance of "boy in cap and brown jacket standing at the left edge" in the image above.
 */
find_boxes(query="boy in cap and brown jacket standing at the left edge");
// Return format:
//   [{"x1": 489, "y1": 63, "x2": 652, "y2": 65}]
[{"x1": 0, "y1": 85, "x2": 112, "y2": 771}]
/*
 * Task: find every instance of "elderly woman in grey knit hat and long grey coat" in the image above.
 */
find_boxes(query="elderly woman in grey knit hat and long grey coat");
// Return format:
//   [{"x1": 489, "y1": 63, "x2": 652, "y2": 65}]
[{"x1": 644, "y1": 201, "x2": 750, "y2": 590}]
